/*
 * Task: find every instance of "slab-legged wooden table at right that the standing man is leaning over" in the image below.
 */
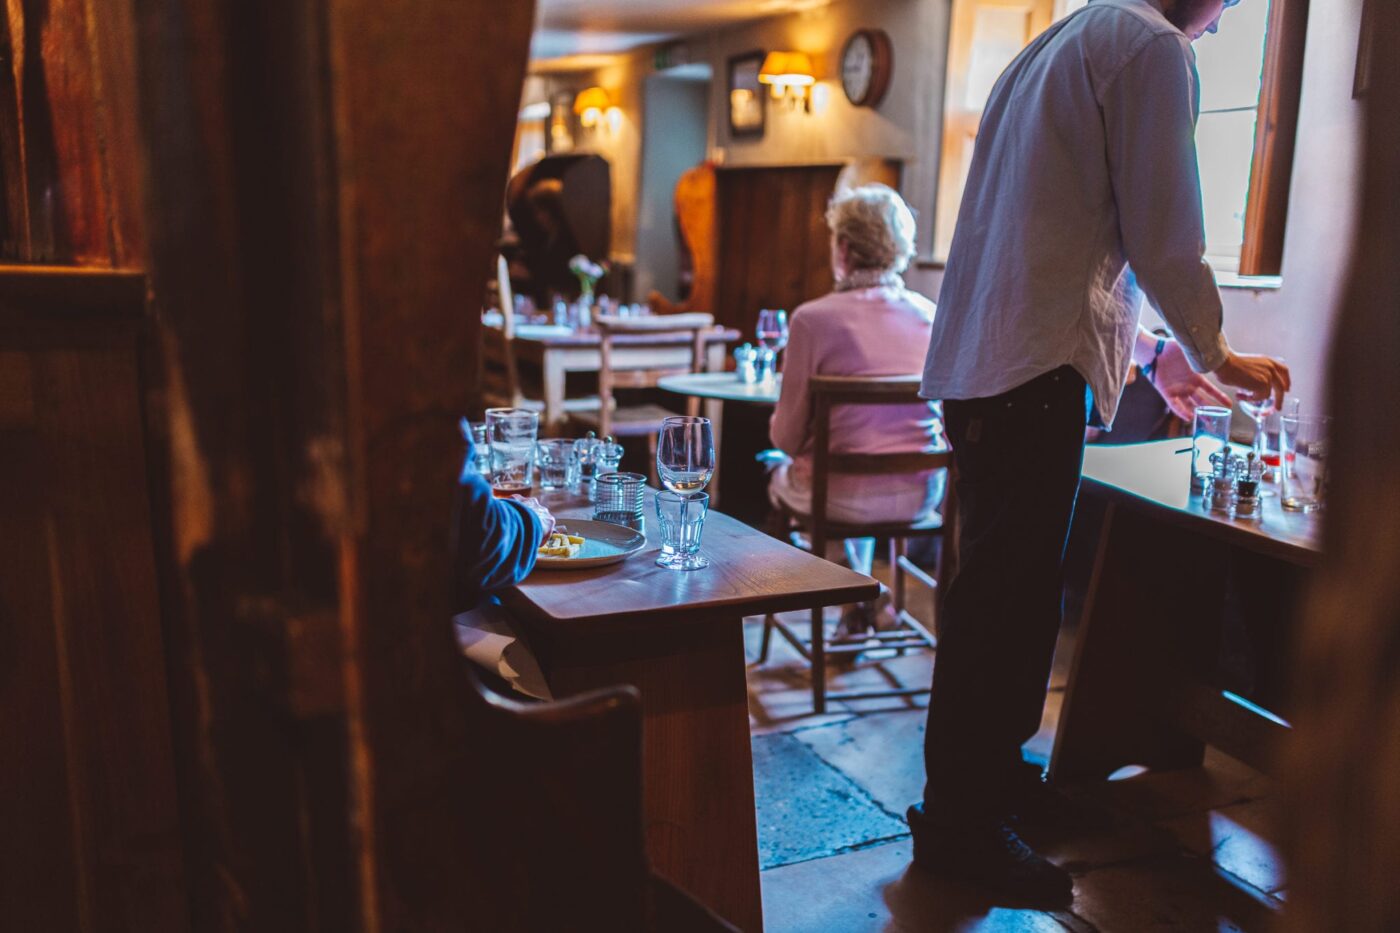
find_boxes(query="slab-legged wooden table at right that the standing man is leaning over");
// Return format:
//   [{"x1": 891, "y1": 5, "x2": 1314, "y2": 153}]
[{"x1": 1050, "y1": 438, "x2": 1320, "y2": 780}]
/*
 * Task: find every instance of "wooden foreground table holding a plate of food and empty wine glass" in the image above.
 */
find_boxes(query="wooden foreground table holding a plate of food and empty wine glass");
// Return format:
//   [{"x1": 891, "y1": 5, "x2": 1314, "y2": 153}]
[{"x1": 503, "y1": 492, "x2": 878, "y2": 933}]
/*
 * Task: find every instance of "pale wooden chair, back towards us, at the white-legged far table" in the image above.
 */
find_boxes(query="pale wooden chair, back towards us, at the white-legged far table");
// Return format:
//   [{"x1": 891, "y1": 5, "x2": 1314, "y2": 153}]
[{"x1": 570, "y1": 312, "x2": 714, "y2": 479}]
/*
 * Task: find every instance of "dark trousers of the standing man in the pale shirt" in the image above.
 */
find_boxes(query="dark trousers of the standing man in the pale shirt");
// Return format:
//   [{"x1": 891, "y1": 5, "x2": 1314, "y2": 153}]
[{"x1": 924, "y1": 366, "x2": 1086, "y2": 822}]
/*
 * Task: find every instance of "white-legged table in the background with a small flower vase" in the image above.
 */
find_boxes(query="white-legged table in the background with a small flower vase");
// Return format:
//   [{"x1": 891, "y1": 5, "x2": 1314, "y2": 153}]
[{"x1": 492, "y1": 324, "x2": 739, "y2": 434}]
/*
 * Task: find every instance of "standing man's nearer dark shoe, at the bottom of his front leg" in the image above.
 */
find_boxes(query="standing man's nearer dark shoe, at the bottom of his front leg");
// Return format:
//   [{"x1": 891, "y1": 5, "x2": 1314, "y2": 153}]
[{"x1": 907, "y1": 804, "x2": 1074, "y2": 908}]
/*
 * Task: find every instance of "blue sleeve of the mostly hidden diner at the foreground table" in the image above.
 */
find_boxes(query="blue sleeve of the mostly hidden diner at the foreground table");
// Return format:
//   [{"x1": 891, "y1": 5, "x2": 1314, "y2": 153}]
[{"x1": 452, "y1": 438, "x2": 543, "y2": 612}]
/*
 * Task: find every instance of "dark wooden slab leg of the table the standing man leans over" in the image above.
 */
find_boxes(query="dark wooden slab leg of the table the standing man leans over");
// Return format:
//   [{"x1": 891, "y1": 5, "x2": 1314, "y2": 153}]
[{"x1": 1050, "y1": 504, "x2": 1225, "y2": 782}]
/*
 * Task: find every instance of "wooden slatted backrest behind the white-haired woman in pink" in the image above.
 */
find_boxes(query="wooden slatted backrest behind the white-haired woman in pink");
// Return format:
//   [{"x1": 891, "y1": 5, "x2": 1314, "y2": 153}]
[{"x1": 808, "y1": 375, "x2": 952, "y2": 545}]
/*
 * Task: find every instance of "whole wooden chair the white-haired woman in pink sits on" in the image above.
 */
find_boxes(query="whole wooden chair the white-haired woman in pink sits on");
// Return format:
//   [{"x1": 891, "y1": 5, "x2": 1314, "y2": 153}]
[{"x1": 759, "y1": 375, "x2": 955, "y2": 713}]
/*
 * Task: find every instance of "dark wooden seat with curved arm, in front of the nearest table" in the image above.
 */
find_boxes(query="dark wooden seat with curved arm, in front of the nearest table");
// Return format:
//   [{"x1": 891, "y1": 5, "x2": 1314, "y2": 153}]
[{"x1": 463, "y1": 661, "x2": 735, "y2": 933}]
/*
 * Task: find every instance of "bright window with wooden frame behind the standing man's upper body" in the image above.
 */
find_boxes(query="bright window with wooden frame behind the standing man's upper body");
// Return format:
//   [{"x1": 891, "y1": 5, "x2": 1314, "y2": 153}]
[{"x1": 934, "y1": 0, "x2": 1308, "y2": 275}]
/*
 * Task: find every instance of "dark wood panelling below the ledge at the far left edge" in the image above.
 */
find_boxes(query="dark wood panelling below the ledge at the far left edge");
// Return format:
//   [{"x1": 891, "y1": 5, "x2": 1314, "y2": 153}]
[{"x1": 0, "y1": 270, "x2": 188, "y2": 930}]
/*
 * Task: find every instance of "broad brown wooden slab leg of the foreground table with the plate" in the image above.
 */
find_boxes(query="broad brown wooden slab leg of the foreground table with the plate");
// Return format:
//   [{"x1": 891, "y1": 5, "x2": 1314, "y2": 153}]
[{"x1": 536, "y1": 618, "x2": 763, "y2": 933}]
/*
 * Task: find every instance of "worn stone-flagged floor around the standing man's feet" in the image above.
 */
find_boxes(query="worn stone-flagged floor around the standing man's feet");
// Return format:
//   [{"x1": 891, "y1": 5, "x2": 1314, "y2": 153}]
[{"x1": 745, "y1": 585, "x2": 1285, "y2": 933}]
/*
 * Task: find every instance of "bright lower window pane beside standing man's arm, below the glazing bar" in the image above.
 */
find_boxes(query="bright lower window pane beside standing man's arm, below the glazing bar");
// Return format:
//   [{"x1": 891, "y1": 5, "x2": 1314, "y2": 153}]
[{"x1": 1196, "y1": 111, "x2": 1254, "y2": 265}]
